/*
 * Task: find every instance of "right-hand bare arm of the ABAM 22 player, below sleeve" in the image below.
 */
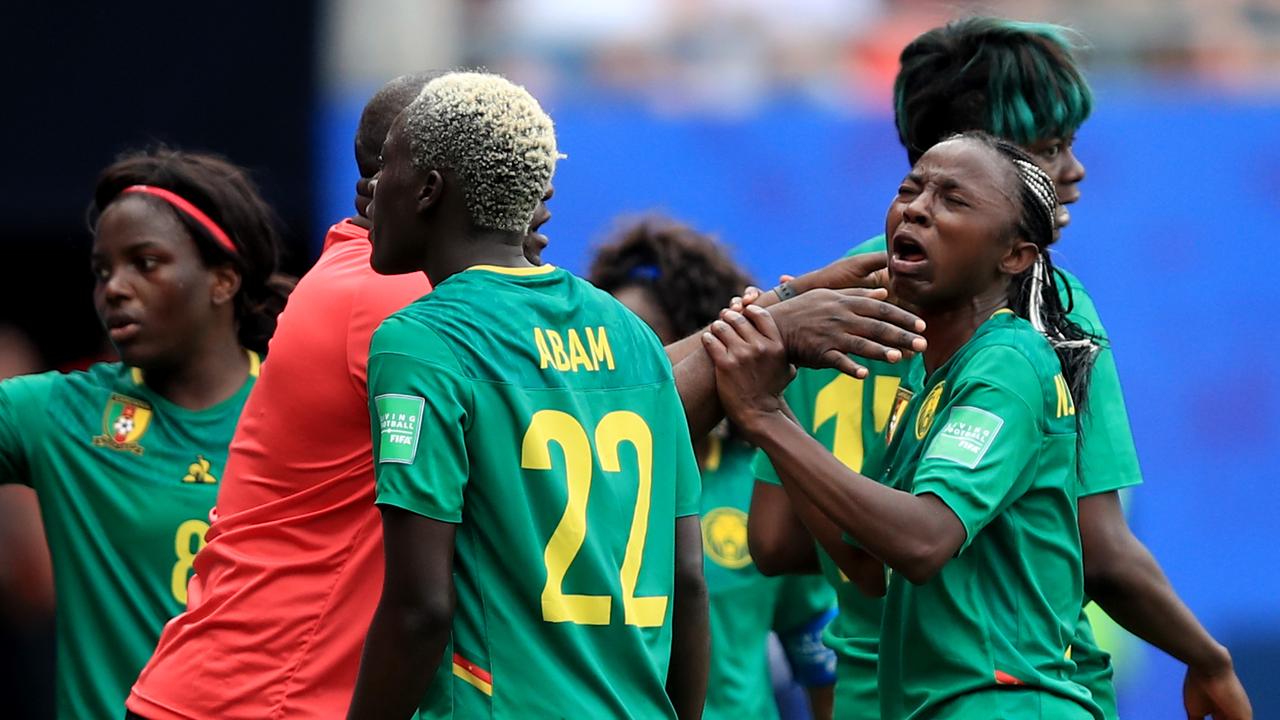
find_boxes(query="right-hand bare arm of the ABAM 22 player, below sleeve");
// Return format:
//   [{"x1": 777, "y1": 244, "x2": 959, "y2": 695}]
[{"x1": 667, "y1": 515, "x2": 712, "y2": 720}]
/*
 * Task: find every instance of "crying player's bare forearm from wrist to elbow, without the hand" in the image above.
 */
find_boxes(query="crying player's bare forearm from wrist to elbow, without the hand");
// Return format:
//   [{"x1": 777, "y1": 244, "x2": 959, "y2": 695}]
[{"x1": 751, "y1": 414, "x2": 964, "y2": 582}]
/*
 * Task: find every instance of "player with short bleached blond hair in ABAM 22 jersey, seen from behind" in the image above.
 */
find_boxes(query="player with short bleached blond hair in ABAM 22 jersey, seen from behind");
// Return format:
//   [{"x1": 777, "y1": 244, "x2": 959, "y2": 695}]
[{"x1": 351, "y1": 73, "x2": 708, "y2": 717}]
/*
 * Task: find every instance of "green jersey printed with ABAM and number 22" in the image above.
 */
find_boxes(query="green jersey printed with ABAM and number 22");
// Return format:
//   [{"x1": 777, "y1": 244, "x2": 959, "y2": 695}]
[{"x1": 369, "y1": 265, "x2": 699, "y2": 719}]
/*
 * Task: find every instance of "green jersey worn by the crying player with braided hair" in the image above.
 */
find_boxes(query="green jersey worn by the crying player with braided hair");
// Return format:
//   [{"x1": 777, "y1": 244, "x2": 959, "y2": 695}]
[{"x1": 879, "y1": 310, "x2": 1102, "y2": 720}]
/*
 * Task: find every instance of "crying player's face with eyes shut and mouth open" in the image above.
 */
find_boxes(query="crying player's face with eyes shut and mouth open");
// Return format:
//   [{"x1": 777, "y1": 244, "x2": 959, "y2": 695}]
[{"x1": 884, "y1": 138, "x2": 1018, "y2": 310}]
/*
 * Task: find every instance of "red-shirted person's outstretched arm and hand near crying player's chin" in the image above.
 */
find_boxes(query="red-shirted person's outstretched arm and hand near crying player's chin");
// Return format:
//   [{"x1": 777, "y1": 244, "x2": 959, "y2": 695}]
[{"x1": 667, "y1": 290, "x2": 925, "y2": 439}]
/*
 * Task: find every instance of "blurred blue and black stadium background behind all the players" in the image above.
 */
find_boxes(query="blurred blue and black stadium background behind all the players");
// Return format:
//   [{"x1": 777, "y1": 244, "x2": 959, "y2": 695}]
[{"x1": 0, "y1": 0, "x2": 1280, "y2": 720}]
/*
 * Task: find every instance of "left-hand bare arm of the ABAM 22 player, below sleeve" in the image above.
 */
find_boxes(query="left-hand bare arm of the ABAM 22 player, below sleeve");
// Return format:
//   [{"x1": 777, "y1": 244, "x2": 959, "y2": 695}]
[{"x1": 347, "y1": 506, "x2": 457, "y2": 720}]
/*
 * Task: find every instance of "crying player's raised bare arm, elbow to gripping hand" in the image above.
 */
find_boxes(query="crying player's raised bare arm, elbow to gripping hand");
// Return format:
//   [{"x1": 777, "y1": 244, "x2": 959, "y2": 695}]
[{"x1": 703, "y1": 306, "x2": 965, "y2": 584}]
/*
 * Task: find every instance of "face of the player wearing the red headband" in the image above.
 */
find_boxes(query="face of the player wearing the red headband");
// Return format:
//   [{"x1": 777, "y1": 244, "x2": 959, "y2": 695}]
[{"x1": 91, "y1": 197, "x2": 230, "y2": 369}]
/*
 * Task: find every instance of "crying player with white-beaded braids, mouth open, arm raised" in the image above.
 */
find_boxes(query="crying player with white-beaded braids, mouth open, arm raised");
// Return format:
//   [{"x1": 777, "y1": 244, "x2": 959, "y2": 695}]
[{"x1": 704, "y1": 133, "x2": 1102, "y2": 720}]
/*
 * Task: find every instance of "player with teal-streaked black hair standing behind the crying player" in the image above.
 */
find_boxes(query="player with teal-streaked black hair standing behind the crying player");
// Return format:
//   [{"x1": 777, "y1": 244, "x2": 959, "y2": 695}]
[{"x1": 753, "y1": 17, "x2": 1251, "y2": 720}]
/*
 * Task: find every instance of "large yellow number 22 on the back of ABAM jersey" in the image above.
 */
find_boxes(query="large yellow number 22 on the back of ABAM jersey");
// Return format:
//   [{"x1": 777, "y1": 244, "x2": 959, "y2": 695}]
[{"x1": 520, "y1": 410, "x2": 667, "y2": 628}]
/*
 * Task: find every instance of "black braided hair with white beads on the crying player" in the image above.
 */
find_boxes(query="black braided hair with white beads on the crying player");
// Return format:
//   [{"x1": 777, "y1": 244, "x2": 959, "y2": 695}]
[{"x1": 948, "y1": 131, "x2": 1101, "y2": 409}]
